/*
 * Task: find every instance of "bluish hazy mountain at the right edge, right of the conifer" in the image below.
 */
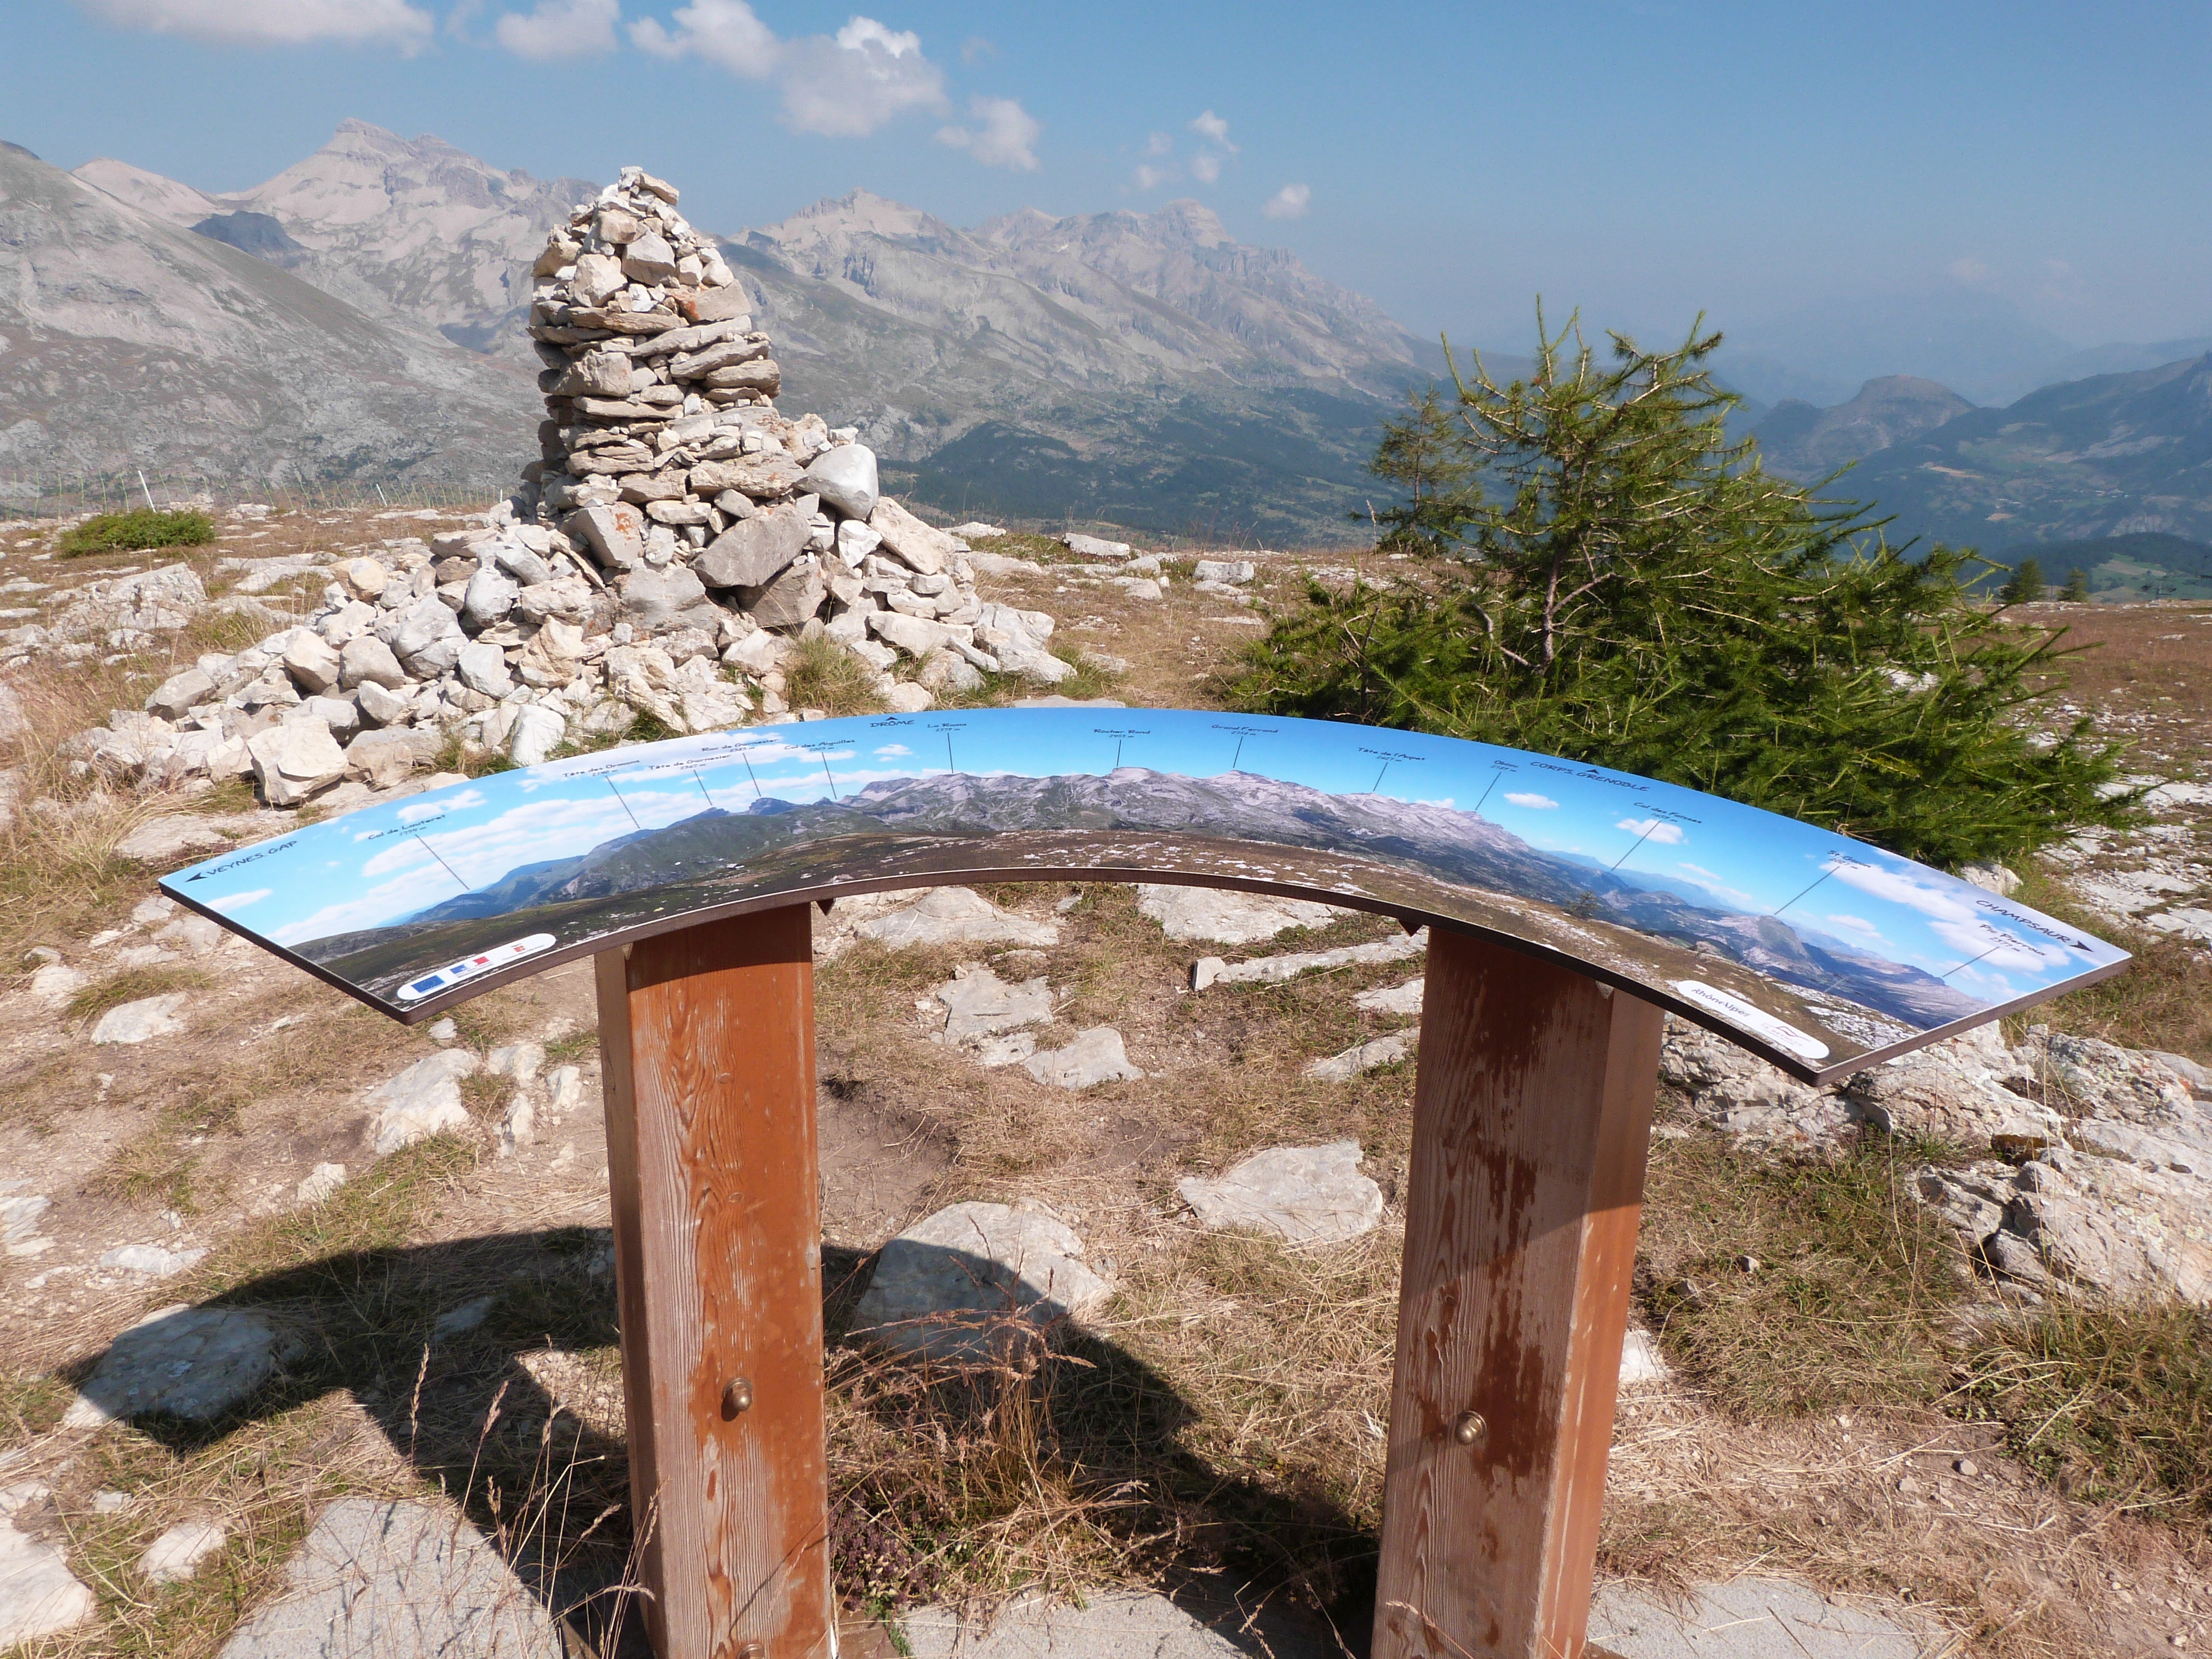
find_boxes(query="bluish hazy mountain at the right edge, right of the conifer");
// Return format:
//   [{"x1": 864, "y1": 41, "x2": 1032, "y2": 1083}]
[{"x1": 1843, "y1": 354, "x2": 2212, "y2": 546}]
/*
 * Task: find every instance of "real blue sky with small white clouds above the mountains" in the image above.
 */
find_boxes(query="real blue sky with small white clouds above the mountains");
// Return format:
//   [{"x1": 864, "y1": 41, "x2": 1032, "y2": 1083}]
[{"x1": 17, "y1": 0, "x2": 2212, "y2": 347}]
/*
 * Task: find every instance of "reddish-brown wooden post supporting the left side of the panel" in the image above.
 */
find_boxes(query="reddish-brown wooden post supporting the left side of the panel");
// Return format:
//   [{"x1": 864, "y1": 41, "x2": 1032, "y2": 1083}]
[{"x1": 597, "y1": 905, "x2": 836, "y2": 1659}]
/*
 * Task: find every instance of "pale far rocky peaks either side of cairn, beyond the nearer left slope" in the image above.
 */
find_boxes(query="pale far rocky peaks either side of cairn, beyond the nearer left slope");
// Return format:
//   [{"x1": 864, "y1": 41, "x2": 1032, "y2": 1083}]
[{"x1": 60, "y1": 122, "x2": 1433, "y2": 540}]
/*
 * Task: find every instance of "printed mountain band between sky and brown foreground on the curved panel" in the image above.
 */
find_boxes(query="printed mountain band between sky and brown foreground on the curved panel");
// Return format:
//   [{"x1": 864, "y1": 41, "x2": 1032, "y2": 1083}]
[{"x1": 301, "y1": 765, "x2": 1980, "y2": 1029}]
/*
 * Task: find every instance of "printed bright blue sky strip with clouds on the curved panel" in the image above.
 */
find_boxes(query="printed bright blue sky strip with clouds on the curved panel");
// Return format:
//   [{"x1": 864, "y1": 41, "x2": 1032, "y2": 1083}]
[{"x1": 168, "y1": 710, "x2": 2119, "y2": 1004}]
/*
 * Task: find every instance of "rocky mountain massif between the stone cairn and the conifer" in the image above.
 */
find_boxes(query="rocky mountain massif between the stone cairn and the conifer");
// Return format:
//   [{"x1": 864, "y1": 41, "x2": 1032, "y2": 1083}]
[{"x1": 726, "y1": 190, "x2": 1429, "y2": 540}]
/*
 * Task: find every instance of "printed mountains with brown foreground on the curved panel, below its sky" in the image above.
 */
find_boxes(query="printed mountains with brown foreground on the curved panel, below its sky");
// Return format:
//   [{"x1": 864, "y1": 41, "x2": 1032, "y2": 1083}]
[{"x1": 296, "y1": 765, "x2": 1989, "y2": 1048}]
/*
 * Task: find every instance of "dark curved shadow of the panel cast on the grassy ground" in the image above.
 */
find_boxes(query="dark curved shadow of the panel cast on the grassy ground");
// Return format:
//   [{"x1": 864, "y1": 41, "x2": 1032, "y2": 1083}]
[{"x1": 71, "y1": 1228, "x2": 1376, "y2": 1659}]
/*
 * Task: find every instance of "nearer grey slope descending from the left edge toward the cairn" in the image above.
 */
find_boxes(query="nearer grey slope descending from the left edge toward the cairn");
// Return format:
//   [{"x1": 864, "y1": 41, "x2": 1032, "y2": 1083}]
[{"x1": 0, "y1": 144, "x2": 535, "y2": 493}]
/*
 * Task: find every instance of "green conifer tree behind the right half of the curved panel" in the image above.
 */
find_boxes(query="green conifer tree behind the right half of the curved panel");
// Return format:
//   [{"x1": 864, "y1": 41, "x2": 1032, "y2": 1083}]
[{"x1": 1228, "y1": 312, "x2": 2130, "y2": 865}]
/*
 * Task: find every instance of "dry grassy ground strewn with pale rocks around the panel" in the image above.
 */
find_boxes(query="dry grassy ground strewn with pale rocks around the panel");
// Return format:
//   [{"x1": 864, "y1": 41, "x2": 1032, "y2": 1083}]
[{"x1": 0, "y1": 511, "x2": 2212, "y2": 1659}]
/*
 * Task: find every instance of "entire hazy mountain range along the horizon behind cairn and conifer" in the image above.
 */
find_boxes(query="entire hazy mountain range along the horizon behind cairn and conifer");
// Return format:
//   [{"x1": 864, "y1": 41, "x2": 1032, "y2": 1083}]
[{"x1": 13, "y1": 122, "x2": 2212, "y2": 566}]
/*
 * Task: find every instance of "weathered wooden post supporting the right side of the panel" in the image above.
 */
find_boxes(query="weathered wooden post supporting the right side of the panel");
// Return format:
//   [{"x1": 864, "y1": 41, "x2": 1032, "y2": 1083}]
[{"x1": 1374, "y1": 927, "x2": 1659, "y2": 1659}]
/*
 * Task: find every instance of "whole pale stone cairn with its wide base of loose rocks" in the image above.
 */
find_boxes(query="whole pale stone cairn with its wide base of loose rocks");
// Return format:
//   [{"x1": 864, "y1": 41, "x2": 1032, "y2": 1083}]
[{"x1": 117, "y1": 168, "x2": 1073, "y2": 805}]
